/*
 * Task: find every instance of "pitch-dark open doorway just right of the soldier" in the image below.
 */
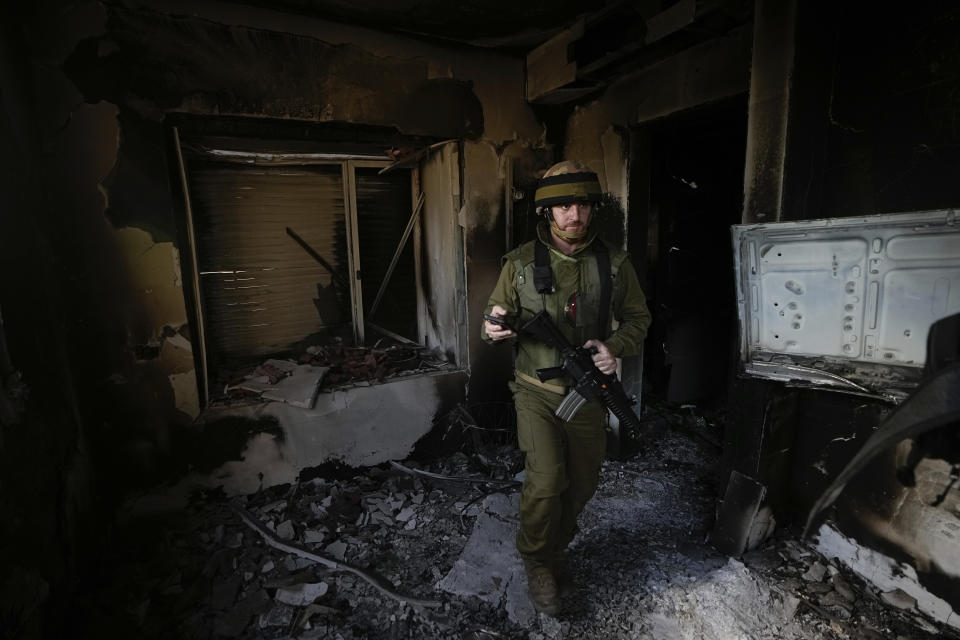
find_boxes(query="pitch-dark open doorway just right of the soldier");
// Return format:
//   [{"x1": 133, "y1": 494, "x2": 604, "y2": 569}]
[{"x1": 631, "y1": 96, "x2": 747, "y2": 406}]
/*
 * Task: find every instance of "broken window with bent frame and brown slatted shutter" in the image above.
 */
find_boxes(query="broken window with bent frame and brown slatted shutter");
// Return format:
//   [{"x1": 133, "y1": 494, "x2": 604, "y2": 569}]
[{"x1": 172, "y1": 131, "x2": 422, "y2": 400}]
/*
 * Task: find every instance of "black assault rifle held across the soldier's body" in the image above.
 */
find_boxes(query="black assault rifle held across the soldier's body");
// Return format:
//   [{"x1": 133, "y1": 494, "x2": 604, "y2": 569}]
[{"x1": 483, "y1": 311, "x2": 643, "y2": 433}]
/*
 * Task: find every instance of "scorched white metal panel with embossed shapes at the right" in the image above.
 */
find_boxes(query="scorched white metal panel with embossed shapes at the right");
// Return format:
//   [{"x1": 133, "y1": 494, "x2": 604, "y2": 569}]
[{"x1": 732, "y1": 210, "x2": 960, "y2": 390}]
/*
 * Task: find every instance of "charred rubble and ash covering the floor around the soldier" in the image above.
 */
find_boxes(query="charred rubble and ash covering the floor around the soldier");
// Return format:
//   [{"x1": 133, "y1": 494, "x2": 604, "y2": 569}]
[{"x1": 78, "y1": 404, "x2": 955, "y2": 640}]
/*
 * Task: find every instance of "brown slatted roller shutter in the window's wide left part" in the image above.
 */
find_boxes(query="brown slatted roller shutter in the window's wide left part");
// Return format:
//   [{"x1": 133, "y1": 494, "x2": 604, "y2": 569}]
[{"x1": 190, "y1": 161, "x2": 352, "y2": 368}]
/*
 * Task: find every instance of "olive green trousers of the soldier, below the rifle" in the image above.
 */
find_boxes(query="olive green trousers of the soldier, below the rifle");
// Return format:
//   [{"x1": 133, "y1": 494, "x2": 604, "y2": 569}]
[{"x1": 510, "y1": 381, "x2": 606, "y2": 563}]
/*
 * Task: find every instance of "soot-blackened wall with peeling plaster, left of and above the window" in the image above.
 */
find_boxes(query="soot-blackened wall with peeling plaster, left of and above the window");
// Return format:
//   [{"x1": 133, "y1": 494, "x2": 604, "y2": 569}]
[{"x1": 0, "y1": 1, "x2": 542, "y2": 628}]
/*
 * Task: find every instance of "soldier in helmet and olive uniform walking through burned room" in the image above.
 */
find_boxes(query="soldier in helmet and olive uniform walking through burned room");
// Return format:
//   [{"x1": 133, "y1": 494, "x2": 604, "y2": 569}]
[{"x1": 483, "y1": 161, "x2": 650, "y2": 616}]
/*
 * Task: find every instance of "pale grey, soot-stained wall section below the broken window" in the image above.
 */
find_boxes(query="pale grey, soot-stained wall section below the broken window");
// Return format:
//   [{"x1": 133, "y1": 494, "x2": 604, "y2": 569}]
[{"x1": 128, "y1": 373, "x2": 465, "y2": 513}]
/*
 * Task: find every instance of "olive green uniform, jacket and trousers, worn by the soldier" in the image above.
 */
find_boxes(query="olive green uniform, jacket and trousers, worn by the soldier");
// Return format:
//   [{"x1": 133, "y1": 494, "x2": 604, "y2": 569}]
[{"x1": 483, "y1": 224, "x2": 650, "y2": 564}]
